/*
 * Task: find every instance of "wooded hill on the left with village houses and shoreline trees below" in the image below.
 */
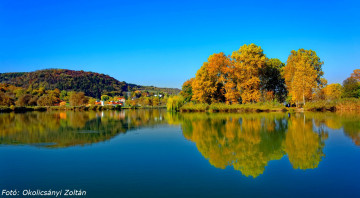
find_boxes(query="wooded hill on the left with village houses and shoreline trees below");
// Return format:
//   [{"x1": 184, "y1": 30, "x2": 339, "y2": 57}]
[{"x1": 0, "y1": 69, "x2": 180, "y2": 112}]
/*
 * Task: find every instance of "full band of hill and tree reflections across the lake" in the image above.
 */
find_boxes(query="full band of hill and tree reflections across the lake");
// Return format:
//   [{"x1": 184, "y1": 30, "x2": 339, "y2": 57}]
[{"x1": 0, "y1": 109, "x2": 360, "y2": 178}]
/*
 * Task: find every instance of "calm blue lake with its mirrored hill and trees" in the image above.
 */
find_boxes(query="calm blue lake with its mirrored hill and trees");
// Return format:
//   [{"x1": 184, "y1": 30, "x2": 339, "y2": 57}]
[{"x1": 0, "y1": 109, "x2": 360, "y2": 197}]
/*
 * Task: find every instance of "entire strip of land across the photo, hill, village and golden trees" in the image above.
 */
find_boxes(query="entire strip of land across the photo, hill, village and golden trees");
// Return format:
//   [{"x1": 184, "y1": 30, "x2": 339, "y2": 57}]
[{"x1": 0, "y1": 44, "x2": 360, "y2": 112}]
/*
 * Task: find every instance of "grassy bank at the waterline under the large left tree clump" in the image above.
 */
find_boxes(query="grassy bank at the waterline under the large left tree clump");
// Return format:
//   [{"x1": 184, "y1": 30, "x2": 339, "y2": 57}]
[{"x1": 180, "y1": 102, "x2": 287, "y2": 112}]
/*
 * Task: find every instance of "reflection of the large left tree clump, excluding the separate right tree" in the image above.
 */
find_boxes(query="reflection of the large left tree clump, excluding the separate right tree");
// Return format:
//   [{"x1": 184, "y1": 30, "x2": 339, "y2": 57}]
[{"x1": 182, "y1": 114, "x2": 287, "y2": 177}]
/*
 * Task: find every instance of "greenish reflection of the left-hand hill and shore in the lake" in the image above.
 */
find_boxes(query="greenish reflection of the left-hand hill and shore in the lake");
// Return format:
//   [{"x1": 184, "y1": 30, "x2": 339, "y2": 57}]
[{"x1": 0, "y1": 109, "x2": 165, "y2": 148}]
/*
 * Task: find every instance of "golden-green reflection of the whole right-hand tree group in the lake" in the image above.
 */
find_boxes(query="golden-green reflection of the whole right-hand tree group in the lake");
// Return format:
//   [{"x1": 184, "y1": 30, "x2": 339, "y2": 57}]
[{"x1": 170, "y1": 113, "x2": 360, "y2": 178}]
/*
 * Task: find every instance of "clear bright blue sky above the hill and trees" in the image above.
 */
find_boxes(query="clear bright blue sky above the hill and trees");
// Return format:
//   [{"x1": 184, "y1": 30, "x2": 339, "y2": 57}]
[{"x1": 0, "y1": 0, "x2": 360, "y2": 88}]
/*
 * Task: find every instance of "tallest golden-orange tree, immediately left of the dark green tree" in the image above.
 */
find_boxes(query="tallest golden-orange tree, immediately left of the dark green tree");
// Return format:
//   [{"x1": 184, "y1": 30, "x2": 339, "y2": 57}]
[{"x1": 231, "y1": 44, "x2": 266, "y2": 103}]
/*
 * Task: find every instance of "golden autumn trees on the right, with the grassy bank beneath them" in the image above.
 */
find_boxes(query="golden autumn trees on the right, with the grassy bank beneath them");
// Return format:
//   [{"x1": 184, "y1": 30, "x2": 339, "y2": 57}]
[{"x1": 167, "y1": 44, "x2": 360, "y2": 112}]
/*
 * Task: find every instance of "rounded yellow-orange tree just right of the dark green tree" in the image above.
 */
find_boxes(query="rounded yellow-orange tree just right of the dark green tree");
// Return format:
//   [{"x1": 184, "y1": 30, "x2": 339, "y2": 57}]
[{"x1": 284, "y1": 49, "x2": 325, "y2": 106}]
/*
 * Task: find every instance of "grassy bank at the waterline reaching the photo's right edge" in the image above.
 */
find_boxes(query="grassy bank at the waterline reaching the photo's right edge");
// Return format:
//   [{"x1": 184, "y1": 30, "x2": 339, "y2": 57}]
[{"x1": 304, "y1": 98, "x2": 360, "y2": 111}]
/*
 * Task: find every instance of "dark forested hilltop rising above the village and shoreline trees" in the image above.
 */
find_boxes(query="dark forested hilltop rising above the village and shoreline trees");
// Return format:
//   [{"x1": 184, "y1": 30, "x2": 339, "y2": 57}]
[{"x1": 0, "y1": 69, "x2": 180, "y2": 98}]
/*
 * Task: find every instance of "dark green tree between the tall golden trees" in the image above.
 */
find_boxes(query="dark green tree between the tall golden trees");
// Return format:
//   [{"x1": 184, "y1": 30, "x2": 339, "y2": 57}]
[{"x1": 260, "y1": 58, "x2": 287, "y2": 102}]
